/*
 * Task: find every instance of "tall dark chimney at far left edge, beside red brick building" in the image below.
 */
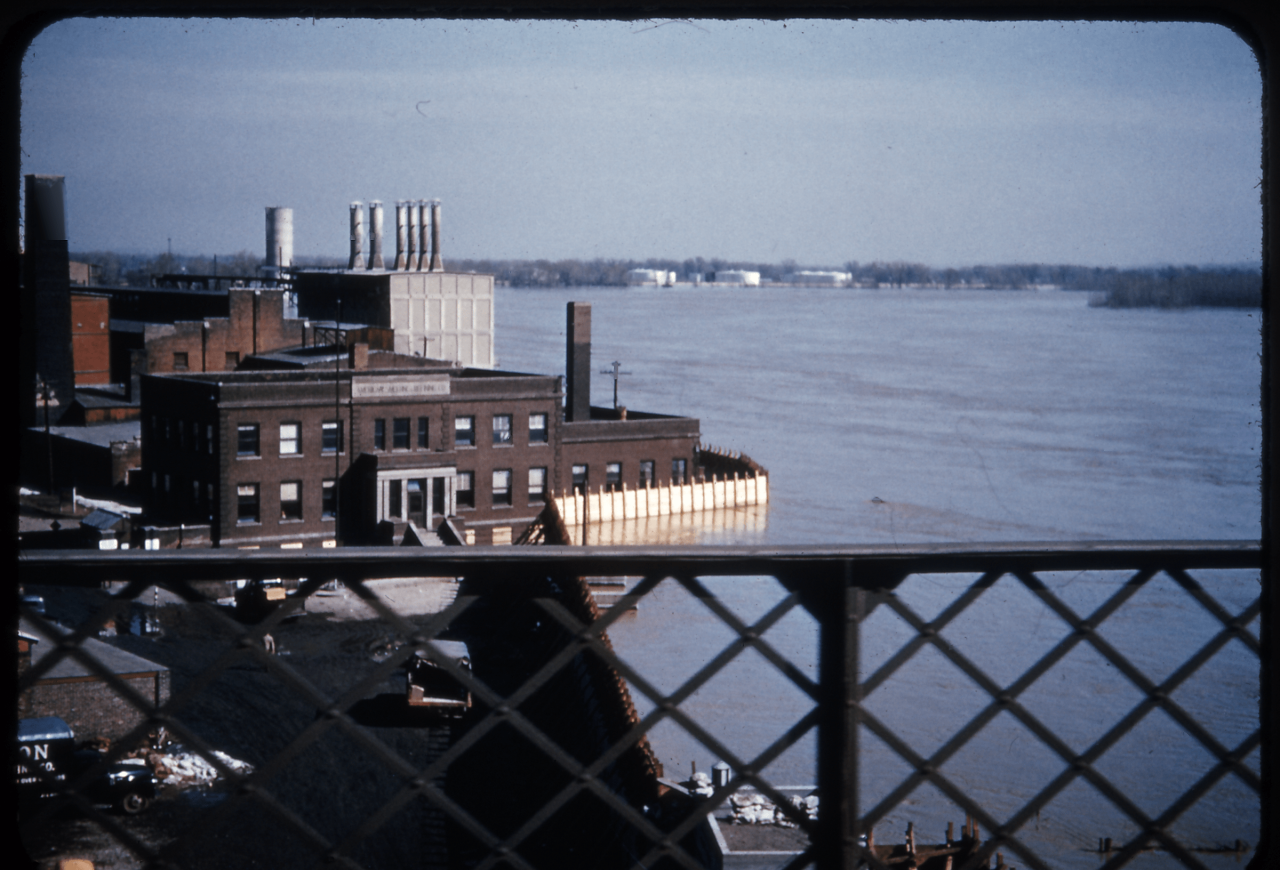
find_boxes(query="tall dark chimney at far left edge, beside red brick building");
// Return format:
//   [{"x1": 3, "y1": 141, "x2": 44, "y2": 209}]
[{"x1": 19, "y1": 175, "x2": 76, "y2": 426}]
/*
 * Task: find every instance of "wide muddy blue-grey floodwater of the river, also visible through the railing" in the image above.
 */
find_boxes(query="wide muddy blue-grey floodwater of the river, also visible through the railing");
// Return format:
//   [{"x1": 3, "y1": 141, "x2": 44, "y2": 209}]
[{"x1": 495, "y1": 288, "x2": 1261, "y2": 867}]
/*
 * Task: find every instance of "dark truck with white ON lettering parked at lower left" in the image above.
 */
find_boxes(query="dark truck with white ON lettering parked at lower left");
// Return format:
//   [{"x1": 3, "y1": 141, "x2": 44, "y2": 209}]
[{"x1": 15, "y1": 716, "x2": 156, "y2": 815}]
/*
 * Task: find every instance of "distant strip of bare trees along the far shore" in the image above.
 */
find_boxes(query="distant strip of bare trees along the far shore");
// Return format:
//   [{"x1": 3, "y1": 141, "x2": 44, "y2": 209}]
[{"x1": 72, "y1": 251, "x2": 1262, "y2": 308}]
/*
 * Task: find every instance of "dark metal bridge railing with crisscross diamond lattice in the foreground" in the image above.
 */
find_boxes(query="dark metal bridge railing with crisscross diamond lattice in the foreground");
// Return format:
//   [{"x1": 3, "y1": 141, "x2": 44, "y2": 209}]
[{"x1": 19, "y1": 541, "x2": 1270, "y2": 870}]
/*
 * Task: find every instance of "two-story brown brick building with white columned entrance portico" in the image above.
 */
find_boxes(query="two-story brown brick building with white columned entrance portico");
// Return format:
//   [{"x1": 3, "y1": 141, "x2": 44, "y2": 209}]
[{"x1": 142, "y1": 324, "x2": 699, "y2": 548}]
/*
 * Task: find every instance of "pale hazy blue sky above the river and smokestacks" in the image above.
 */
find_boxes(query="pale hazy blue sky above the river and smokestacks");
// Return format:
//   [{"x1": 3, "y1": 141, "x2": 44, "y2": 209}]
[{"x1": 22, "y1": 19, "x2": 1262, "y2": 267}]
